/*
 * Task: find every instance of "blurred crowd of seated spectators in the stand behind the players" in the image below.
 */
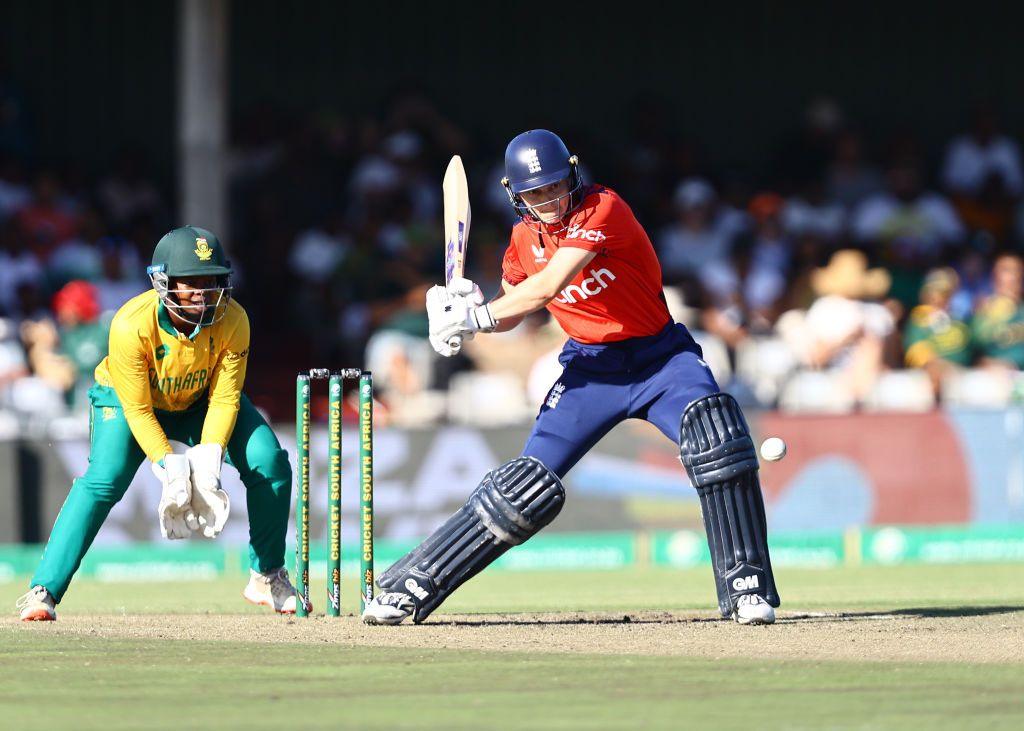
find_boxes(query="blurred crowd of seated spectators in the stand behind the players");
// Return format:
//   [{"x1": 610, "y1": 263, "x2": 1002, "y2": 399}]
[{"x1": 6, "y1": 85, "x2": 1024, "y2": 425}]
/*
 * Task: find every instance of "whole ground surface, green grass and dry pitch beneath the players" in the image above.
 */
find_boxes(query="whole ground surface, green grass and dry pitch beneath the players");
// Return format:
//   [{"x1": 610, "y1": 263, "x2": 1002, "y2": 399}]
[{"x1": 0, "y1": 565, "x2": 1024, "y2": 729}]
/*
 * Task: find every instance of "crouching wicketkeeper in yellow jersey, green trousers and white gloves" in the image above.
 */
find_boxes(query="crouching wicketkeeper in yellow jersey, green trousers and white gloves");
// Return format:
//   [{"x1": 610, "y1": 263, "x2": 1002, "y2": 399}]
[{"x1": 17, "y1": 226, "x2": 295, "y2": 621}]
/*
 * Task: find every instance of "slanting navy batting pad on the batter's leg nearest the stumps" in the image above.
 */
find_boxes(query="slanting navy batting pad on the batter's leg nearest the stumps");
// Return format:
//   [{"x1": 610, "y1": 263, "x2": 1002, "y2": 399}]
[{"x1": 377, "y1": 457, "x2": 565, "y2": 622}]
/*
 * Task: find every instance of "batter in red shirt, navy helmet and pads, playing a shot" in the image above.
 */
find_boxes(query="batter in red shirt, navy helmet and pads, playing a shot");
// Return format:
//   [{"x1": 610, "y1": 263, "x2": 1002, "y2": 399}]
[{"x1": 362, "y1": 130, "x2": 779, "y2": 625}]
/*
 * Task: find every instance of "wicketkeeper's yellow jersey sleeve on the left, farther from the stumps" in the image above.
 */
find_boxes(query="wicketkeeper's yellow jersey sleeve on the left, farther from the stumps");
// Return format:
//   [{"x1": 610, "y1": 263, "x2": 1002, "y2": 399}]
[{"x1": 105, "y1": 309, "x2": 171, "y2": 462}]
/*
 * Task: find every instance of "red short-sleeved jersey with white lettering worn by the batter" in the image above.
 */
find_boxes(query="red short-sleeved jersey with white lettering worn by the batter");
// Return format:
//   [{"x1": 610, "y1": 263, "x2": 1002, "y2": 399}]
[{"x1": 502, "y1": 185, "x2": 672, "y2": 343}]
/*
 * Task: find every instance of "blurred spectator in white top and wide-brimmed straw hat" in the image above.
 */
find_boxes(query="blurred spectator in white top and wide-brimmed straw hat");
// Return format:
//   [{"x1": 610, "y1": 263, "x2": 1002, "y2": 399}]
[{"x1": 778, "y1": 249, "x2": 895, "y2": 401}]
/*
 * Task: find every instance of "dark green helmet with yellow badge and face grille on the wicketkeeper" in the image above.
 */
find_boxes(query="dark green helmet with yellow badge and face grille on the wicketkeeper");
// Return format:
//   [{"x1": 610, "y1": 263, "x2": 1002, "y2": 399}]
[{"x1": 145, "y1": 226, "x2": 231, "y2": 328}]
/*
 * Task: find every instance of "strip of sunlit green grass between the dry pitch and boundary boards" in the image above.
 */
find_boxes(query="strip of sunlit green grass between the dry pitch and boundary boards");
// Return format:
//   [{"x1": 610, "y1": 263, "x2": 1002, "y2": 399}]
[{"x1": 0, "y1": 564, "x2": 1024, "y2": 610}]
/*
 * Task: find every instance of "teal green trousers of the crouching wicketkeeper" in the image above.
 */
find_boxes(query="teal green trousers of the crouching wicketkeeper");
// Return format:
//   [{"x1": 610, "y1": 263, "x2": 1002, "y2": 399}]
[{"x1": 30, "y1": 385, "x2": 292, "y2": 602}]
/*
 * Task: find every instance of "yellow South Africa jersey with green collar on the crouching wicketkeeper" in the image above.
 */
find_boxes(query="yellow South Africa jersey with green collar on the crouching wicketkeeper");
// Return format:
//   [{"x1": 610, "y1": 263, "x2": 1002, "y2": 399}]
[{"x1": 95, "y1": 290, "x2": 249, "y2": 462}]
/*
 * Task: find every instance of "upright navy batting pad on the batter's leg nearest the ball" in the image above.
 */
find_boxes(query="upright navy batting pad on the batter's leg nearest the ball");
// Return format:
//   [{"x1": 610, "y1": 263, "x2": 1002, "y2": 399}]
[{"x1": 679, "y1": 393, "x2": 779, "y2": 616}]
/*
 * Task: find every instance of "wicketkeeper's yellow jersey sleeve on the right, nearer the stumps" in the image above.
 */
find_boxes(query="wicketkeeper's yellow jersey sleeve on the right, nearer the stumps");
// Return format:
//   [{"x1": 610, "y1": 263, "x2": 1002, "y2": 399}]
[{"x1": 201, "y1": 307, "x2": 249, "y2": 449}]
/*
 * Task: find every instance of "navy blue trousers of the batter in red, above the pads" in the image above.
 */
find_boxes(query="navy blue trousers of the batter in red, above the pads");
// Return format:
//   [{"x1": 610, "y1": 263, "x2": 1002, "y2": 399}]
[{"x1": 522, "y1": 324, "x2": 720, "y2": 477}]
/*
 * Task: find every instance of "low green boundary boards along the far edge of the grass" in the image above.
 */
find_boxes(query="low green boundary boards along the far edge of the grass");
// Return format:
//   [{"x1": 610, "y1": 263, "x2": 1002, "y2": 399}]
[{"x1": 6, "y1": 524, "x2": 1024, "y2": 583}]
